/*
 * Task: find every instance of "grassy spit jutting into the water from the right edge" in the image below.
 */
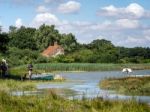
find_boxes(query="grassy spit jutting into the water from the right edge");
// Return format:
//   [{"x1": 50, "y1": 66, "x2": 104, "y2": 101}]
[{"x1": 100, "y1": 77, "x2": 150, "y2": 96}]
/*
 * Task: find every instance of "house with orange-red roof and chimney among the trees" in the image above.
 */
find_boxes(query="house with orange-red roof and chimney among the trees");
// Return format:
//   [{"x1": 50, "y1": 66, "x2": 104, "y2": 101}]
[{"x1": 42, "y1": 42, "x2": 64, "y2": 57}]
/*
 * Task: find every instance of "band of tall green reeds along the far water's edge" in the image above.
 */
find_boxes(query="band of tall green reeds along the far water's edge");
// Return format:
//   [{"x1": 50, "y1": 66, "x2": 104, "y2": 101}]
[{"x1": 12, "y1": 63, "x2": 150, "y2": 72}]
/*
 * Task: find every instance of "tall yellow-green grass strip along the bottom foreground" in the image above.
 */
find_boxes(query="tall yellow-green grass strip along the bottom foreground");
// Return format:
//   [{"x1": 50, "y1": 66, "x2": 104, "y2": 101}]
[{"x1": 0, "y1": 92, "x2": 150, "y2": 112}]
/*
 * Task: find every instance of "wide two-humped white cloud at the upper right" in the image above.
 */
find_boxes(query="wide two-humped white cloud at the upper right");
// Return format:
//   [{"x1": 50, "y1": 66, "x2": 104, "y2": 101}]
[{"x1": 97, "y1": 3, "x2": 150, "y2": 19}]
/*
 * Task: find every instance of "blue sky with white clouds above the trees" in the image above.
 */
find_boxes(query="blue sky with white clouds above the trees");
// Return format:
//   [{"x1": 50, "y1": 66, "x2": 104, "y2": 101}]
[{"x1": 0, "y1": 0, "x2": 150, "y2": 47}]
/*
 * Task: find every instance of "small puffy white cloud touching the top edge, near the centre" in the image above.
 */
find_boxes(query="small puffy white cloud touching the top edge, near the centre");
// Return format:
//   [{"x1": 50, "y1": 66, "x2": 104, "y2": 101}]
[{"x1": 58, "y1": 1, "x2": 81, "y2": 14}]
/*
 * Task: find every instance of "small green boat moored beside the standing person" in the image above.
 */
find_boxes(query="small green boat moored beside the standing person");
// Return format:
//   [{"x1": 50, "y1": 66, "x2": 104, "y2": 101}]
[{"x1": 31, "y1": 73, "x2": 54, "y2": 80}]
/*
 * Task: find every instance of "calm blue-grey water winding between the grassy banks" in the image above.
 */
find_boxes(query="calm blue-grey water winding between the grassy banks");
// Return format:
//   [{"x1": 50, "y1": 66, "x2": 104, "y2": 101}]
[{"x1": 37, "y1": 70, "x2": 150, "y2": 103}]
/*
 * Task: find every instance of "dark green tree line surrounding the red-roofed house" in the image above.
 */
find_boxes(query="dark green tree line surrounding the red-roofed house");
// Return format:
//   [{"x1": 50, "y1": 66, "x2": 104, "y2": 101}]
[{"x1": 0, "y1": 24, "x2": 150, "y2": 65}]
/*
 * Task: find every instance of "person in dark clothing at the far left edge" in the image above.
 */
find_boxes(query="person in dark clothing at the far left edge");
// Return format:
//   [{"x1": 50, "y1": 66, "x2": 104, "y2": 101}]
[{"x1": 0, "y1": 59, "x2": 8, "y2": 77}]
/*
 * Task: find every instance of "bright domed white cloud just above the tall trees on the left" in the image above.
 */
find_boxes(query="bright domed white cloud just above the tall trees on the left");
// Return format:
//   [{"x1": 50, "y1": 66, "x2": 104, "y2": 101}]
[{"x1": 32, "y1": 13, "x2": 59, "y2": 27}]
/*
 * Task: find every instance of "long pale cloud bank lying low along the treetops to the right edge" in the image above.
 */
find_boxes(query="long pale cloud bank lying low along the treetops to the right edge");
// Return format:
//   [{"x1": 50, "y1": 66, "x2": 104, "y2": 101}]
[{"x1": 32, "y1": 13, "x2": 150, "y2": 47}]
